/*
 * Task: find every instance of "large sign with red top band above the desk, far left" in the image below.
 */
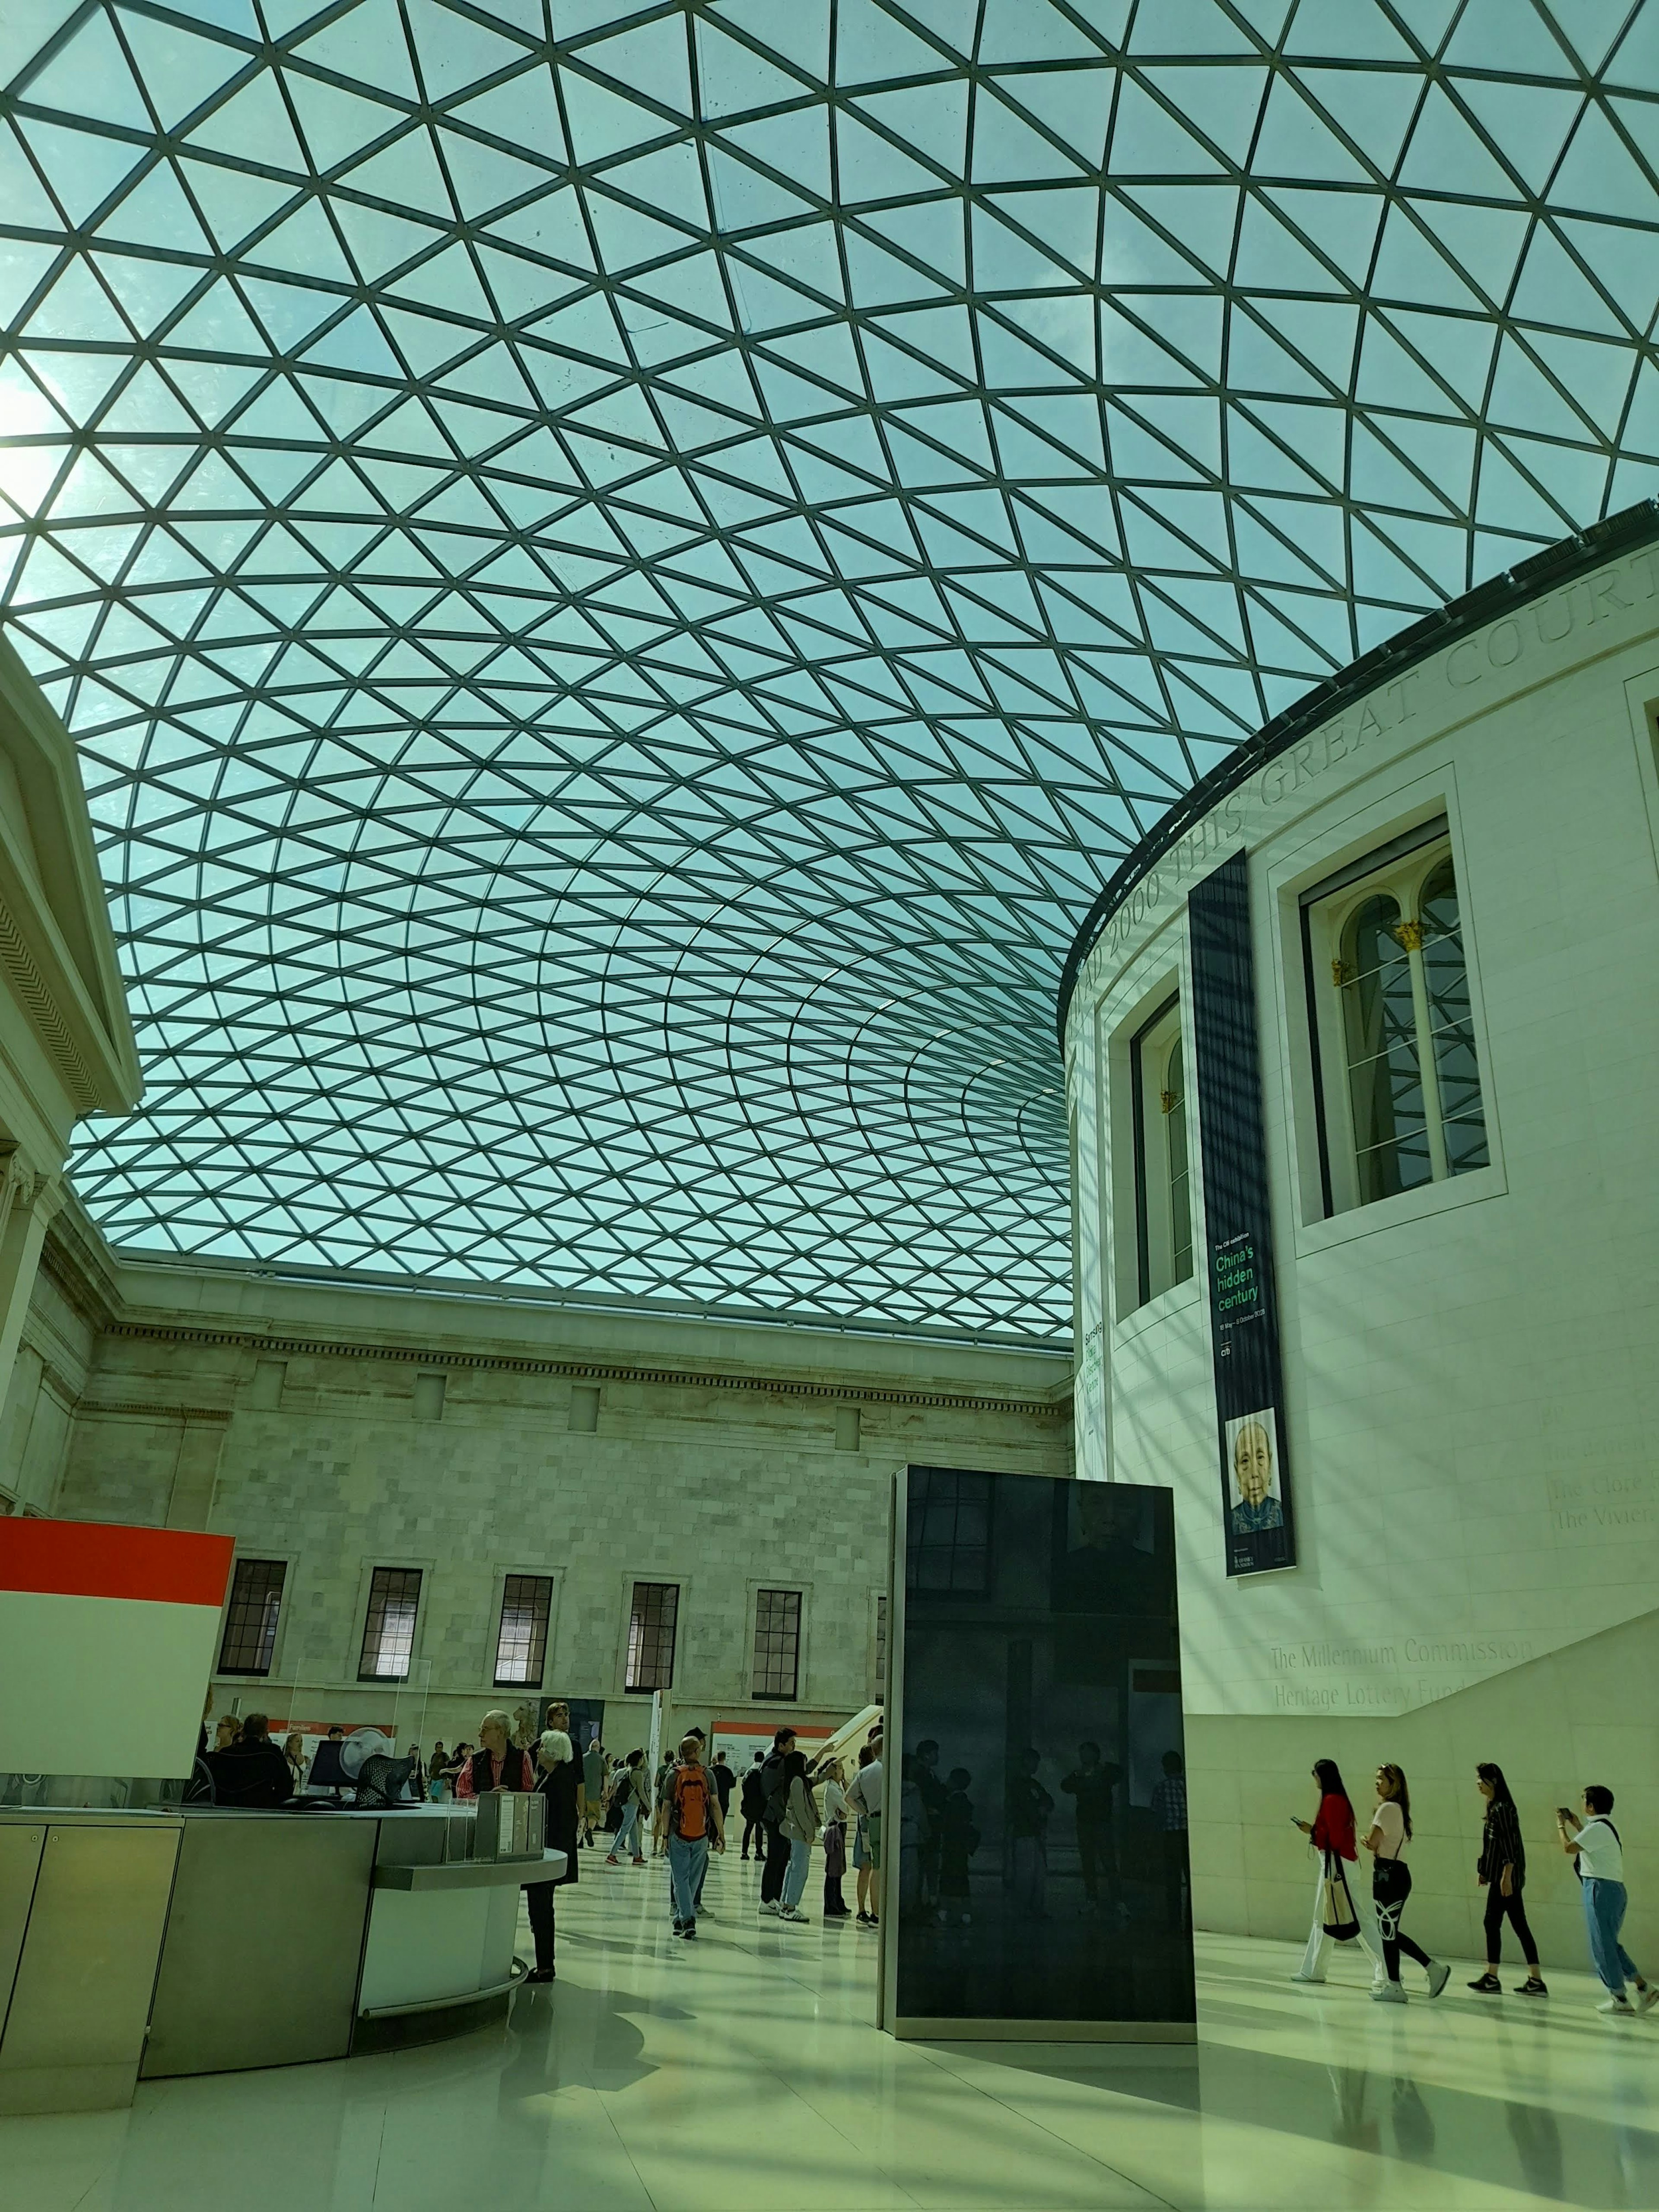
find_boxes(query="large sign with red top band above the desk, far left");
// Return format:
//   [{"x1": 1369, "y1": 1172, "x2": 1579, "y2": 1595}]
[{"x1": 0, "y1": 1517, "x2": 237, "y2": 1776}]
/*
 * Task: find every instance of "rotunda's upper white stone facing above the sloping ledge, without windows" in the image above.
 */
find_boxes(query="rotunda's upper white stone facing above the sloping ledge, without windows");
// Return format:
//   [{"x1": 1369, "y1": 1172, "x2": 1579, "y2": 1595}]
[{"x1": 1068, "y1": 540, "x2": 1659, "y2": 1725}]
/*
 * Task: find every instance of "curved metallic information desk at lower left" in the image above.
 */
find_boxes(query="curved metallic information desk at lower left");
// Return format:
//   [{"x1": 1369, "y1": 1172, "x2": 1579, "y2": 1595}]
[{"x1": 0, "y1": 1805, "x2": 564, "y2": 2113}]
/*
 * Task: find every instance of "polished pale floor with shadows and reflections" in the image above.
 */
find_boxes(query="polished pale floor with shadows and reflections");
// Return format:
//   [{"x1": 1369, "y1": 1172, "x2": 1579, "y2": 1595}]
[{"x1": 13, "y1": 1851, "x2": 1659, "y2": 2212}]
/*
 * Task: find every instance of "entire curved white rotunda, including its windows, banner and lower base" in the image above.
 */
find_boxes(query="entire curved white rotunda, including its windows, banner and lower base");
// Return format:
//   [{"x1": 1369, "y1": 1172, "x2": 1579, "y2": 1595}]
[{"x1": 1064, "y1": 509, "x2": 1659, "y2": 1949}]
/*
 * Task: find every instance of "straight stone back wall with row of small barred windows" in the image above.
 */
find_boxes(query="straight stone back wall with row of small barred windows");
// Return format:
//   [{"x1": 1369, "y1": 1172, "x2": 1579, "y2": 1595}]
[{"x1": 42, "y1": 1268, "x2": 1071, "y2": 1741}]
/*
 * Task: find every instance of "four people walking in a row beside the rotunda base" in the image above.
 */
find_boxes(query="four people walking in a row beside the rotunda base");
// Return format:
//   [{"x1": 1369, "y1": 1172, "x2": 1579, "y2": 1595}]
[{"x1": 1292, "y1": 1758, "x2": 1659, "y2": 2015}]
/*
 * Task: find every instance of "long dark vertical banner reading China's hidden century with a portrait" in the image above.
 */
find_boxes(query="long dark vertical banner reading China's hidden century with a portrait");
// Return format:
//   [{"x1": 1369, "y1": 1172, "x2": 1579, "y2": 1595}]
[{"x1": 1185, "y1": 852, "x2": 1296, "y2": 1575}]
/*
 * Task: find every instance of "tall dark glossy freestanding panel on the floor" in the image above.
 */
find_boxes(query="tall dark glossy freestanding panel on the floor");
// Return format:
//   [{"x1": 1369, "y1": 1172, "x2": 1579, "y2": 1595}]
[{"x1": 898, "y1": 1467, "x2": 1195, "y2": 2033}]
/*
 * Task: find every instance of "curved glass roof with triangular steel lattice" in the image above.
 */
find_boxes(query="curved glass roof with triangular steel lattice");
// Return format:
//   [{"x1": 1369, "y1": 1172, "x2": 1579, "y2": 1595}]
[{"x1": 0, "y1": 0, "x2": 1659, "y2": 1336}]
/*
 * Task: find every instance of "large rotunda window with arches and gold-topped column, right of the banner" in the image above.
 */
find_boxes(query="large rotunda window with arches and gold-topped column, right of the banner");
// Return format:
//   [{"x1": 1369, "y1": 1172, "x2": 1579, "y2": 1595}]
[{"x1": 1301, "y1": 818, "x2": 1491, "y2": 1214}]
